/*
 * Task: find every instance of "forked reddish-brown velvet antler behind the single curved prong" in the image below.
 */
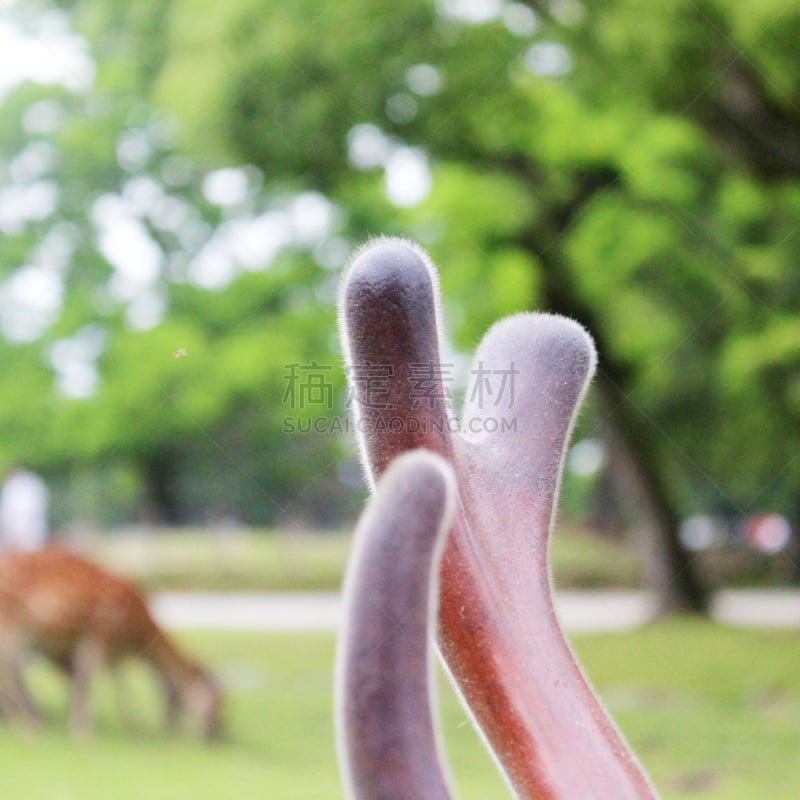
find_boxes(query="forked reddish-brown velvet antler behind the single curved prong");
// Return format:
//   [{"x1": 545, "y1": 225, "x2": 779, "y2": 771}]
[{"x1": 340, "y1": 239, "x2": 654, "y2": 800}]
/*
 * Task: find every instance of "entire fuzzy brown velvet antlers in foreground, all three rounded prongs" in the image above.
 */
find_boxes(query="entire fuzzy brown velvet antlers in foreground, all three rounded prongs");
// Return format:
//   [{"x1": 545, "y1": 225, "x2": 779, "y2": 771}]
[{"x1": 335, "y1": 238, "x2": 657, "y2": 800}]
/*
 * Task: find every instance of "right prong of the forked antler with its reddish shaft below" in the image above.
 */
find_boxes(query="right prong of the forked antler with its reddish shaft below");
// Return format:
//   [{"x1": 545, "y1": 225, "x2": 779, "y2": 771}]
[{"x1": 440, "y1": 314, "x2": 653, "y2": 800}]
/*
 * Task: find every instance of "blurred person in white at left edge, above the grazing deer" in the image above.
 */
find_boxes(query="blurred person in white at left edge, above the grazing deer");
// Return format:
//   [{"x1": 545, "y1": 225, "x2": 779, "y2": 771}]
[{"x1": 0, "y1": 467, "x2": 48, "y2": 550}]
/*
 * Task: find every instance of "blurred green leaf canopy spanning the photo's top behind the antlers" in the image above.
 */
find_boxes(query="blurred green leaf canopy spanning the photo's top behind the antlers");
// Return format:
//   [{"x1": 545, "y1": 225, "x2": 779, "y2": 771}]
[{"x1": 0, "y1": 0, "x2": 800, "y2": 524}]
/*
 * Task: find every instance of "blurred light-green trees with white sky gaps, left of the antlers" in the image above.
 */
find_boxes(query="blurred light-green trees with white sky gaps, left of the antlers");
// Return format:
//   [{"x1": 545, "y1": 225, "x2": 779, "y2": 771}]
[{"x1": 0, "y1": 9, "x2": 355, "y2": 525}]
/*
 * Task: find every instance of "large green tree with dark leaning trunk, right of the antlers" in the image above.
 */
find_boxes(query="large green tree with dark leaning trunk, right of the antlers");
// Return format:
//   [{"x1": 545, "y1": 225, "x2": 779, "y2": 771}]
[{"x1": 6, "y1": 0, "x2": 800, "y2": 609}]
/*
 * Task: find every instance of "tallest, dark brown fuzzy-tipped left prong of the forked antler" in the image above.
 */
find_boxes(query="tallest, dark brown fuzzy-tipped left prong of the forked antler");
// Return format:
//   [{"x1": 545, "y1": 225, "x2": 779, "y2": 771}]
[{"x1": 339, "y1": 237, "x2": 451, "y2": 483}]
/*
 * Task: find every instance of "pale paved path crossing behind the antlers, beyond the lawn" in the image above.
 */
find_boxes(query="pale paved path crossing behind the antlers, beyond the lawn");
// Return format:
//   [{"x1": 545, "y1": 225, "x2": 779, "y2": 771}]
[{"x1": 153, "y1": 590, "x2": 800, "y2": 632}]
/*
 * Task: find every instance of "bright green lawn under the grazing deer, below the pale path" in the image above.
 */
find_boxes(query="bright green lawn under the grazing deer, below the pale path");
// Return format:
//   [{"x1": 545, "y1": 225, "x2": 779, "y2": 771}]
[{"x1": 0, "y1": 620, "x2": 800, "y2": 800}]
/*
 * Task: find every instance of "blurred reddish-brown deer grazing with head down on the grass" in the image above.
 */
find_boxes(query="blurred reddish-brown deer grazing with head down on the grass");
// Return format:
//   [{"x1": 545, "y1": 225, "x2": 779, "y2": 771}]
[{"x1": 0, "y1": 547, "x2": 221, "y2": 739}]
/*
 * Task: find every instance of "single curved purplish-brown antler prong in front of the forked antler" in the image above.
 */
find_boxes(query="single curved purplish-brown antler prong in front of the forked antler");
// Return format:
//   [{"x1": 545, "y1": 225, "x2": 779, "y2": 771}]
[{"x1": 335, "y1": 450, "x2": 455, "y2": 800}]
